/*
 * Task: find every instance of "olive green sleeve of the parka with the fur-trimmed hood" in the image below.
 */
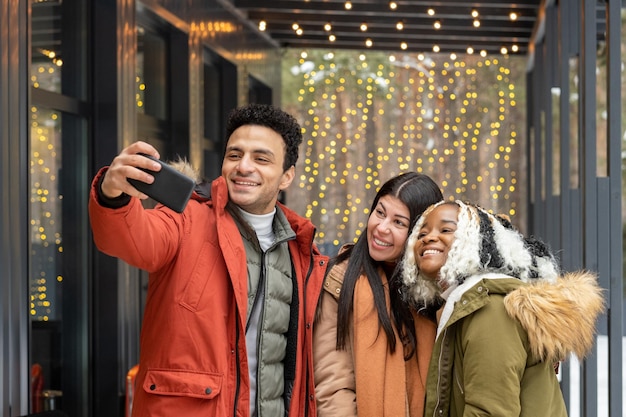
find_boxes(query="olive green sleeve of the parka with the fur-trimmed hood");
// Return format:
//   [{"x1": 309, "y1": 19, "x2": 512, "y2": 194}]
[{"x1": 453, "y1": 295, "x2": 529, "y2": 417}]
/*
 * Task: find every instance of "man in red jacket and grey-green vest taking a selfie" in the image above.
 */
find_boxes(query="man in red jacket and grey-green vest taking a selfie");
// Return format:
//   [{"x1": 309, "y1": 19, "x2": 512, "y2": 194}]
[{"x1": 89, "y1": 105, "x2": 327, "y2": 417}]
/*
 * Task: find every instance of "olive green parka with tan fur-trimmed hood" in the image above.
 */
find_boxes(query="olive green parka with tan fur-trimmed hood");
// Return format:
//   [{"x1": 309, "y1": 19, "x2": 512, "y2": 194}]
[{"x1": 424, "y1": 272, "x2": 603, "y2": 417}]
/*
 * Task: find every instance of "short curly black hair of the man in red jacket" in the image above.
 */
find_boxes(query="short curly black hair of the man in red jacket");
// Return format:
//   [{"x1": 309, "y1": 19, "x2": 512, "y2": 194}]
[{"x1": 226, "y1": 104, "x2": 302, "y2": 171}]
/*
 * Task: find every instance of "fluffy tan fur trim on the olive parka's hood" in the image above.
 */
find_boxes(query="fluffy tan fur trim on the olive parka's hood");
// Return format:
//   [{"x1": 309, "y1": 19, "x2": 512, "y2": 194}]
[{"x1": 504, "y1": 271, "x2": 604, "y2": 361}]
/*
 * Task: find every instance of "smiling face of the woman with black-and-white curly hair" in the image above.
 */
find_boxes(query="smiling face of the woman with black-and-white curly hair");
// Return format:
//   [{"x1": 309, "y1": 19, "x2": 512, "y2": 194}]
[{"x1": 413, "y1": 204, "x2": 459, "y2": 280}]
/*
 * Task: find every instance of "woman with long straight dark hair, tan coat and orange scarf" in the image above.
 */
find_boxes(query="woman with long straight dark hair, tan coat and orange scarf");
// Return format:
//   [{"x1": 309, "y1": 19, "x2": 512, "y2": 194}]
[{"x1": 313, "y1": 172, "x2": 443, "y2": 417}]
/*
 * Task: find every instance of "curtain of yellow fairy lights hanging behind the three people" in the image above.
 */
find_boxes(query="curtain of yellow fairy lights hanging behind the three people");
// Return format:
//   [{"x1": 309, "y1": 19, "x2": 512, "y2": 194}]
[{"x1": 283, "y1": 51, "x2": 523, "y2": 248}]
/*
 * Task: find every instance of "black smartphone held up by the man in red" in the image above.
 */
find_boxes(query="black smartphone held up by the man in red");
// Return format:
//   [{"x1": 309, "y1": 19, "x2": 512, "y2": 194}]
[{"x1": 127, "y1": 153, "x2": 196, "y2": 213}]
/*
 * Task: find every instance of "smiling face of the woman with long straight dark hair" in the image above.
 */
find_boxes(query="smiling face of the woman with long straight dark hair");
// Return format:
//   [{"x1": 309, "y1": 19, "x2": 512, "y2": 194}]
[{"x1": 367, "y1": 195, "x2": 410, "y2": 262}]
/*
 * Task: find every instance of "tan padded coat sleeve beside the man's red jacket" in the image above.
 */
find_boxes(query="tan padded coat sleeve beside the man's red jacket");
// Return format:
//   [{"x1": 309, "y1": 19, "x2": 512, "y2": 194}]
[{"x1": 313, "y1": 277, "x2": 357, "y2": 417}]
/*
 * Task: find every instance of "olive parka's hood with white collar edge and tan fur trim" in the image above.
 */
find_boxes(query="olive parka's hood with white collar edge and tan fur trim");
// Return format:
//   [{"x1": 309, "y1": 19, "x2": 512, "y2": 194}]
[{"x1": 437, "y1": 271, "x2": 604, "y2": 362}]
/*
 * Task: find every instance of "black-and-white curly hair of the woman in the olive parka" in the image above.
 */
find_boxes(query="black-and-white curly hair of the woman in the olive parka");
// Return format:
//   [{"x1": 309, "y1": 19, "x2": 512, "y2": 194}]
[{"x1": 401, "y1": 200, "x2": 559, "y2": 306}]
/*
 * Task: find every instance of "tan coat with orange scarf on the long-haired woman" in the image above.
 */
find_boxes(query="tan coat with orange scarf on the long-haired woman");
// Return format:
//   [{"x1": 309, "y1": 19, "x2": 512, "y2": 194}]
[{"x1": 313, "y1": 262, "x2": 436, "y2": 417}]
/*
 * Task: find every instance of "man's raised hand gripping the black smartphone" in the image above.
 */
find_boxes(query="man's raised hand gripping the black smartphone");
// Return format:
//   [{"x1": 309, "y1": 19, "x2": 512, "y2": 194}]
[{"x1": 101, "y1": 141, "x2": 161, "y2": 200}]
